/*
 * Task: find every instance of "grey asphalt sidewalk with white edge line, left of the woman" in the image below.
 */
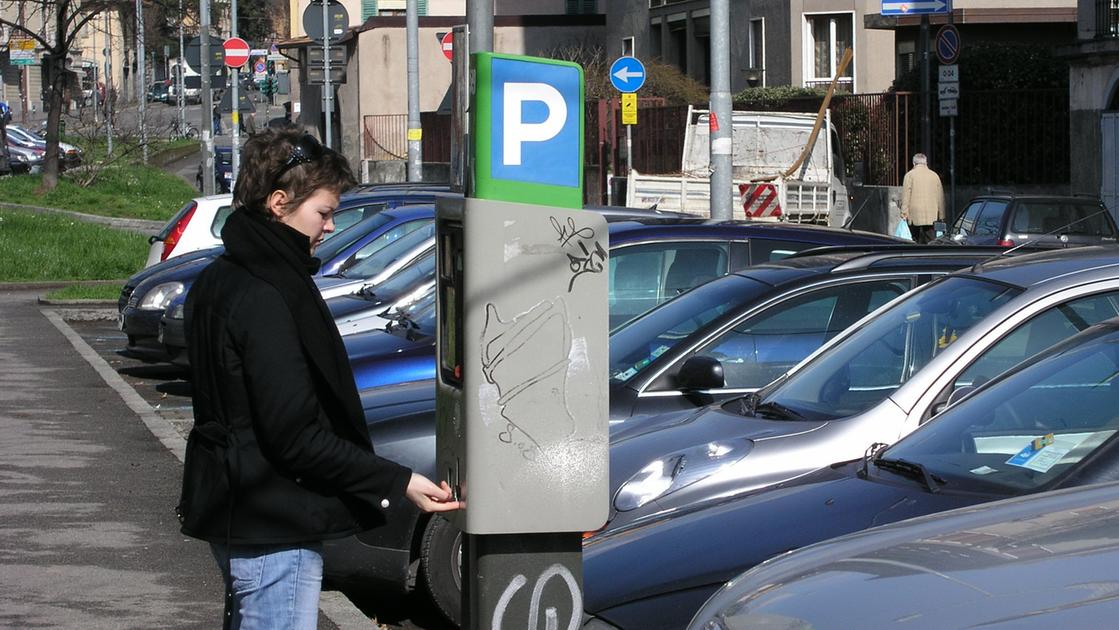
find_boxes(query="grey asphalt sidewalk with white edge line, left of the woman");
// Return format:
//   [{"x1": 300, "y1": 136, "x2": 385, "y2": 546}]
[{"x1": 0, "y1": 290, "x2": 353, "y2": 630}]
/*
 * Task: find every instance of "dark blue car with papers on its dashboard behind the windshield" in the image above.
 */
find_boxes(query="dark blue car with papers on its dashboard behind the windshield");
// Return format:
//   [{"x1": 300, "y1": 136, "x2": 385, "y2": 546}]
[{"x1": 583, "y1": 321, "x2": 1119, "y2": 630}]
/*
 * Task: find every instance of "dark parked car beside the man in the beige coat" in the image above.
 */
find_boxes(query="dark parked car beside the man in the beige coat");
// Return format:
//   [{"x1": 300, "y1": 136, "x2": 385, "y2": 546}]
[{"x1": 940, "y1": 194, "x2": 1119, "y2": 247}]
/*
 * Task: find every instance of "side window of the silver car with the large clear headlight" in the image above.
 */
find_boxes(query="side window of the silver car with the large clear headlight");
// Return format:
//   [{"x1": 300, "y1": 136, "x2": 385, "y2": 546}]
[{"x1": 952, "y1": 292, "x2": 1119, "y2": 388}]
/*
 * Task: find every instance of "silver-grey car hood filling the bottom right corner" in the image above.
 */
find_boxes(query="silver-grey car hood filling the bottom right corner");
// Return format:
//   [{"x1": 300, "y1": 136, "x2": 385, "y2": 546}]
[{"x1": 688, "y1": 482, "x2": 1119, "y2": 630}]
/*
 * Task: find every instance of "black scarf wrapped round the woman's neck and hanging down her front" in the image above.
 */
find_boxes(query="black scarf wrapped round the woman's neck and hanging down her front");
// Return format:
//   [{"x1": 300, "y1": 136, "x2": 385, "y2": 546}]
[{"x1": 222, "y1": 208, "x2": 369, "y2": 444}]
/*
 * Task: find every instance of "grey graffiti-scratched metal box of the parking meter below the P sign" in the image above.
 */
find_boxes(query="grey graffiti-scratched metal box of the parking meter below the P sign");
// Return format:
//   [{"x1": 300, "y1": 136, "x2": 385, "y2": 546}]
[{"x1": 436, "y1": 198, "x2": 609, "y2": 534}]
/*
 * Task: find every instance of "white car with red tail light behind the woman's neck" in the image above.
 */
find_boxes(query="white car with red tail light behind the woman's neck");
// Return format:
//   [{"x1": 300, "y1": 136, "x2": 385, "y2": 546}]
[{"x1": 144, "y1": 194, "x2": 233, "y2": 267}]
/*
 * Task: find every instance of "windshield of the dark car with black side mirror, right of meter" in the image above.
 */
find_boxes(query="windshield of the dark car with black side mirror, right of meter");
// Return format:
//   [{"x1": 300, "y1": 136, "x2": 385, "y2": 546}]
[{"x1": 610, "y1": 274, "x2": 771, "y2": 383}]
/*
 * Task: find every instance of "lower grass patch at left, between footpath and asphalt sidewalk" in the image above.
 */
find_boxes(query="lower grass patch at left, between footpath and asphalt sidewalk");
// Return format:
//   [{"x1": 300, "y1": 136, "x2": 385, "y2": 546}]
[{"x1": 0, "y1": 207, "x2": 148, "y2": 282}]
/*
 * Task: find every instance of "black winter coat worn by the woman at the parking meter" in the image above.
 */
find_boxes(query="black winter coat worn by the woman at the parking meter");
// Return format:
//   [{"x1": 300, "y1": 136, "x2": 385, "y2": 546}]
[{"x1": 178, "y1": 210, "x2": 411, "y2": 544}]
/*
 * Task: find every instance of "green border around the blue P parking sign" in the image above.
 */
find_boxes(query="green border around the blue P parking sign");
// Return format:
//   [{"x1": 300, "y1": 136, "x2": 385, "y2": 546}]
[{"x1": 470, "y1": 53, "x2": 585, "y2": 208}]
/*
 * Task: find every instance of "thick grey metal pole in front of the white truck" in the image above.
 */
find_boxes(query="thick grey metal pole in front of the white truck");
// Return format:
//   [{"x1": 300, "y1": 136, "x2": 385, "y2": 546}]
[{"x1": 707, "y1": 0, "x2": 734, "y2": 220}]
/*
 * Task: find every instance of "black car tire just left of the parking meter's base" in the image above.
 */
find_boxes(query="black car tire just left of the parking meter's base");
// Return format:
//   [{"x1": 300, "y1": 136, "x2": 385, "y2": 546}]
[{"x1": 420, "y1": 516, "x2": 462, "y2": 626}]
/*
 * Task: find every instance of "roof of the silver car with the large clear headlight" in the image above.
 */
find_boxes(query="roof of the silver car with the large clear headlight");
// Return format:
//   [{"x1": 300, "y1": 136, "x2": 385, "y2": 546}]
[{"x1": 961, "y1": 245, "x2": 1119, "y2": 289}]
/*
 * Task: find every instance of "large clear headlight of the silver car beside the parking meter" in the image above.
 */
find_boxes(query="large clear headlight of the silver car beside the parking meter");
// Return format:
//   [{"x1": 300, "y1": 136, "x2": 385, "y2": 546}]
[{"x1": 614, "y1": 438, "x2": 754, "y2": 511}]
